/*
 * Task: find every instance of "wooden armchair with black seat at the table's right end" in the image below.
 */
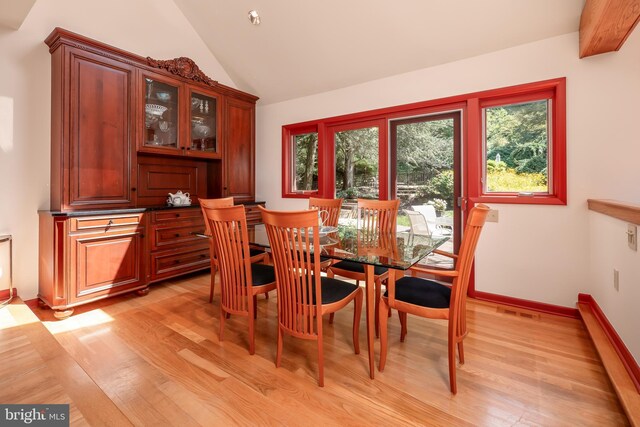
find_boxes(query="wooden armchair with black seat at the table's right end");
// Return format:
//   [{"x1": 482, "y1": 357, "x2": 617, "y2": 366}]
[{"x1": 379, "y1": 204, "x2": 489, "y2": 394}]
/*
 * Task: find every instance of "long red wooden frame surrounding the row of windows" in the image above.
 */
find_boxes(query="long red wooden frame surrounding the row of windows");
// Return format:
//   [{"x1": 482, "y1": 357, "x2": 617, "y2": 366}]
[{"x1": 282, "y1": 77, "x2": 567, "y2": 205}]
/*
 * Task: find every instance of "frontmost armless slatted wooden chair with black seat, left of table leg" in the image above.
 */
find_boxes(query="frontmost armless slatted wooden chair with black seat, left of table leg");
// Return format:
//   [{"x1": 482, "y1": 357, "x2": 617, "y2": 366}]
[{"x1": 261, "y1": 207, "x2": 363, "y2": 387}]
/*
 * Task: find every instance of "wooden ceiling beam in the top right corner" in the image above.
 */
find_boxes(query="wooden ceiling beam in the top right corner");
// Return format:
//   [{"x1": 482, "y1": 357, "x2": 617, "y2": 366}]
[{"x1": 580, "y1": 0, "x2": 640, "y2": 58}]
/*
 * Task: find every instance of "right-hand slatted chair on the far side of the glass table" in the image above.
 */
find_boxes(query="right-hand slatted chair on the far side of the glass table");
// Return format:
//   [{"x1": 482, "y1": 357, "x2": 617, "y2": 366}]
[{"x1": 327, "y1": 199, "x2": 400, "y2": 336}]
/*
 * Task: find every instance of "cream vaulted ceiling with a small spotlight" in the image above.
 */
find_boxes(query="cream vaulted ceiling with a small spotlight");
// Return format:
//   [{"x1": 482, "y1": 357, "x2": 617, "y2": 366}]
[{"x1": 174, "y1": 0, "x2": 584, "y2": 104}]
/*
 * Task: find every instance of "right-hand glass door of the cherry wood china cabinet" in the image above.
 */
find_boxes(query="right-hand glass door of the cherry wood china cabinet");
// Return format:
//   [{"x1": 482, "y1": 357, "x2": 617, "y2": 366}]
[{"x1": 188, "y1": 91, "x2": 218, "y2": 154}]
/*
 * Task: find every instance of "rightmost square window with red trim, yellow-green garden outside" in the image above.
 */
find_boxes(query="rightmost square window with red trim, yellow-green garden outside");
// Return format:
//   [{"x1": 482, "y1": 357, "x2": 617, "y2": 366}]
[{"x1": 469, "y1": 79, "x2": 566, "y2": 204}]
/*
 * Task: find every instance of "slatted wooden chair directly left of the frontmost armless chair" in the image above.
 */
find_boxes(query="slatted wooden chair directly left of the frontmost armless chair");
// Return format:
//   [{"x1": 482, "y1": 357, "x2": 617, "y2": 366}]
[{"x1": 206, "y1": 206, "x2": 276, "y2": 354}]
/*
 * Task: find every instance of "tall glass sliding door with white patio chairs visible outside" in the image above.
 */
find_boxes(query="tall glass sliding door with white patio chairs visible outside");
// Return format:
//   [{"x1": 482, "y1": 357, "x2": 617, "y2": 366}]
[{"x1": 390, "y1": 111, "x2": 462, "y2": 268}]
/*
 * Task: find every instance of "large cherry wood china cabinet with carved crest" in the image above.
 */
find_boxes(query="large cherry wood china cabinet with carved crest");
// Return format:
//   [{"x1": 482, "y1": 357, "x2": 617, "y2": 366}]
[{"x1": 39, "y1": 28, "x2": 260, "y2": 318}]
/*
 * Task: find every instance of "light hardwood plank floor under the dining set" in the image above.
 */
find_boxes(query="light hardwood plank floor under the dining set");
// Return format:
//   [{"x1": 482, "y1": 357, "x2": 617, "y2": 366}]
[{"x1": 0, "y1": 274, "x2": 628, "y2": 426}]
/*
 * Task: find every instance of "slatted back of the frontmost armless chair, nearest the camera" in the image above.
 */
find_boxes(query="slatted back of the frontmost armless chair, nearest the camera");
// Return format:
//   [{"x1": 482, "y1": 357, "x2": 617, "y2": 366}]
[{"x1": 262, "y1": 210, "x2": 322, "y2": 339}]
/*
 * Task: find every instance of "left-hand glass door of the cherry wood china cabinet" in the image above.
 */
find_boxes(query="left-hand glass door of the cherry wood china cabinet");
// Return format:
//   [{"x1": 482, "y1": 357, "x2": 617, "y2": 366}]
[{"x1": 143, "y1": 77, "x2": 180, "y2": 149}]
